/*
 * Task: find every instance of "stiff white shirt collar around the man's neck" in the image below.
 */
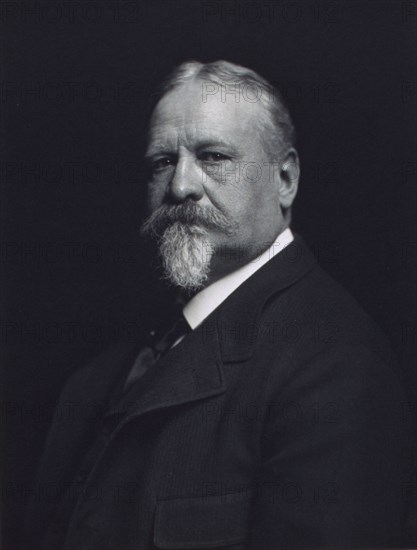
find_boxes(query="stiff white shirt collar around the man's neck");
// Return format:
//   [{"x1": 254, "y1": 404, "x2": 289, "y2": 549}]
[{"x1": 183, "y1": 228, "x2": 294, "y2": 330}]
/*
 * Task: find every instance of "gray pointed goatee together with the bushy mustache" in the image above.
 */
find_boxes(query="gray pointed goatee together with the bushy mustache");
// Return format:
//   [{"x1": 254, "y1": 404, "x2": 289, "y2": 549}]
[{"x1": 141, "y1": 201, "x2": 236, "y2": 292}]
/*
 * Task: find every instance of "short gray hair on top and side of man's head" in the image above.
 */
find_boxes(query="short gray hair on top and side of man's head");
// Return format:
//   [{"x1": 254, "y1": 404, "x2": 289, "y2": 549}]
[{"x1": 148, "y1": 60, "x2": 296, "y2": 160}]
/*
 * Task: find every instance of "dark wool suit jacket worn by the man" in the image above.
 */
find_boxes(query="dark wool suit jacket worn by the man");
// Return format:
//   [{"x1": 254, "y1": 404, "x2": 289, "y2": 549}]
[{"x1": 28, "y1": 237, "x2": 408, "y2": 550}]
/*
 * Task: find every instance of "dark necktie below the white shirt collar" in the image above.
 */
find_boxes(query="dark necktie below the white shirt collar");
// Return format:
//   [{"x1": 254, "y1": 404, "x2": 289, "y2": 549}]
[{"x1": 124, "y1": 311, "x2": 191, "y2": 391}]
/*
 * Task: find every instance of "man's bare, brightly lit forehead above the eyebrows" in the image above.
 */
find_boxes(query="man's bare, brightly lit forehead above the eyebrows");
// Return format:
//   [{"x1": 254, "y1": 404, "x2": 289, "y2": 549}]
[{"x1": 149, "y1": 80, "x2": 262, "y2": 151}]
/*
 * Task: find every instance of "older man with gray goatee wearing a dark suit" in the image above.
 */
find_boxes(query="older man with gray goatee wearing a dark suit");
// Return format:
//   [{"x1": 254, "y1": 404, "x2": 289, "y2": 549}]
[{"x1": 28, "y1": 61, "x2": 407, "y2": 550}]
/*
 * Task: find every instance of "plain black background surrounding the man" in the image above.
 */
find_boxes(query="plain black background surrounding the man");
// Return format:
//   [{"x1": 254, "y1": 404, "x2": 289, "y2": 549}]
[{"x1": 0, "y1": 0, "x2": 416, "y2": 550}]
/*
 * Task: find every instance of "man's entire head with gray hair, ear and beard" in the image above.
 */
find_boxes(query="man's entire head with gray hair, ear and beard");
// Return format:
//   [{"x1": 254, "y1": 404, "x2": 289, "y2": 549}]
[{"x1": 142, "y1": 61, "x2": 299, "y2": 291}]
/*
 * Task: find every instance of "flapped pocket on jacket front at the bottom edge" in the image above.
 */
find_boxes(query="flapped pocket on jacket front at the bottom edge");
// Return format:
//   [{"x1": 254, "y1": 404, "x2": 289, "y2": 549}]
[{"x1": 154, "y1": 493, "x2": 252, "y2": 549}]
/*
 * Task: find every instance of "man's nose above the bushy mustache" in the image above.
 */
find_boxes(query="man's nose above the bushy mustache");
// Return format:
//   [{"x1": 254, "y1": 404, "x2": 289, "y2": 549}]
[{"x1": 169, "y1": 156, "x2": 204, "y2": 203}]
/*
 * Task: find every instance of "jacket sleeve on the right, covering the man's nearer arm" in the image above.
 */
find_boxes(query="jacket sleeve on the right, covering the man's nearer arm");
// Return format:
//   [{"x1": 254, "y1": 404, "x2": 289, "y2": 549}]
[{"x1": 251, "y1": 346, "x2": 409, "y2": 550}]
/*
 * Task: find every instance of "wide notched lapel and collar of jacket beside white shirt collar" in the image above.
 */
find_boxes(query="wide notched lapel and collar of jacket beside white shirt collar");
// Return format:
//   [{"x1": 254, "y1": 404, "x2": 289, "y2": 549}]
[{"x1": 102, "y1": 236, "x2": 315, "y2": 420}]
